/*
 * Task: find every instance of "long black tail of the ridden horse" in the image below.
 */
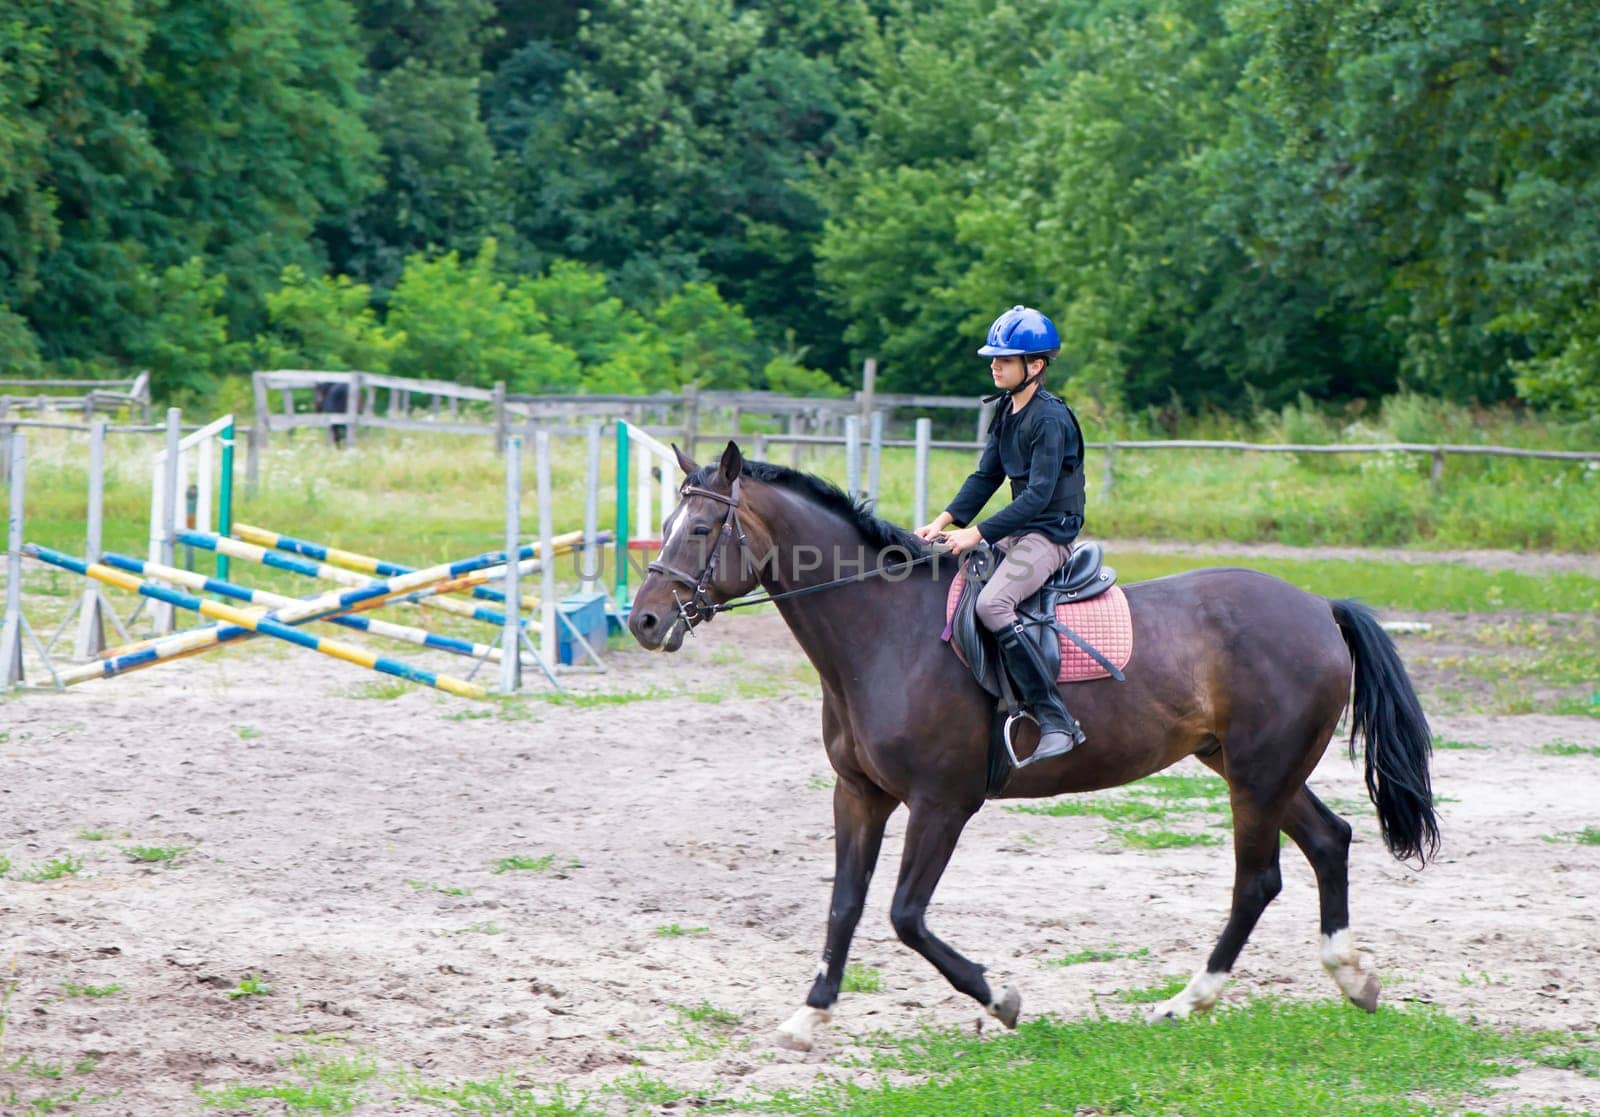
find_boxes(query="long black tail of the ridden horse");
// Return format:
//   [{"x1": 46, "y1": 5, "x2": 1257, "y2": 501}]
[{"x1": 1330, "y1": 602, "x2": 1438, "y2": 863}]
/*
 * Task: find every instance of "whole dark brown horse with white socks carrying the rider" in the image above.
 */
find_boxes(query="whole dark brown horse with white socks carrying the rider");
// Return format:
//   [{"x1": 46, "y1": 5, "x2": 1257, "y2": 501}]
[{"x1": 629, "y1": 442, "x2": 1438, "y2": 1048}]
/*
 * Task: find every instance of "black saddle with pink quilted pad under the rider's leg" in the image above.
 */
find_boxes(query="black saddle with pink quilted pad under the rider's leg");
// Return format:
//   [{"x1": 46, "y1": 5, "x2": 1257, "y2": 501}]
[{"x1": 944, "y1": 542, "x2": 1133, "y2": 698}]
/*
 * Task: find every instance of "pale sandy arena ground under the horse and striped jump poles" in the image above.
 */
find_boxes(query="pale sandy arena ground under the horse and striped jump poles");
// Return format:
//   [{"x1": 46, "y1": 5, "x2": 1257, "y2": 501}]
[{"x1": 0, "y1": 566, "x2": 1600, "y2": 1115}]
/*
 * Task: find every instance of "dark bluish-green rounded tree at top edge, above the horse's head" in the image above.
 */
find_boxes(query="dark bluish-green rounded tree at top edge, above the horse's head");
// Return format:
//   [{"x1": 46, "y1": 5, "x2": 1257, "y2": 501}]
[{"x1": 488, "y1": 0, "x2": 870, "y2": 374}]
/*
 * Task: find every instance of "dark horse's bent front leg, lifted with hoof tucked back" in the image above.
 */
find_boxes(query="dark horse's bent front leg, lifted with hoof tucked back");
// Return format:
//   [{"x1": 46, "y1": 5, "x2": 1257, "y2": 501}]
[{"x1": 890, "y1": 800, "x2": 1022, "y2": 1027}]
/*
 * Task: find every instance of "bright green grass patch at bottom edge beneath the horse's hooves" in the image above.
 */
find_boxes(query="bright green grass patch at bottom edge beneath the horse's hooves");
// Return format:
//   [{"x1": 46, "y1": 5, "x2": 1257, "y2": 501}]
[{"x1": 757, "y1": 983, "x2": 1570, "y2": 1117}]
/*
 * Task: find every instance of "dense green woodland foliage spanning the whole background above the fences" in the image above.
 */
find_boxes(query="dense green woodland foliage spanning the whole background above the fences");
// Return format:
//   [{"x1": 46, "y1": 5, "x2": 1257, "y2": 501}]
[{"x1": 0, "y1": 0, "x2": 1600, "y2": 414}]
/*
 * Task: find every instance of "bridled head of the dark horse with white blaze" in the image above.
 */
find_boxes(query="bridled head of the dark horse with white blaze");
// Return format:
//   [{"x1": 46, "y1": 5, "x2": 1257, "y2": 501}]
[{"x1": 627, "y1": 442, "x2": 757, "y2": 651}]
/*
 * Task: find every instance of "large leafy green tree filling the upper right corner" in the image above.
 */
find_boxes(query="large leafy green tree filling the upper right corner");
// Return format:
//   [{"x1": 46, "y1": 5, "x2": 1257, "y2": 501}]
[{"x1": 1237, "y1": 0, "x2": 1600, "y2": 398}]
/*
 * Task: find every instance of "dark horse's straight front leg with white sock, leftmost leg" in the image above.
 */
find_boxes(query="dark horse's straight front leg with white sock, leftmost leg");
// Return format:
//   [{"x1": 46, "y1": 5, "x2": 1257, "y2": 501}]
[{"x1": 778, "y1": 776, "x2": 898, "y2": 1051}]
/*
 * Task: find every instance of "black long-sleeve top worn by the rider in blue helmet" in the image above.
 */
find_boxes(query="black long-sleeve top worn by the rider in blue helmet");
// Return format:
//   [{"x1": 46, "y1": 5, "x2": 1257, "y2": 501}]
[{"x1": 946, "y1": 389, "x2": 1083, "y2": 542}]
